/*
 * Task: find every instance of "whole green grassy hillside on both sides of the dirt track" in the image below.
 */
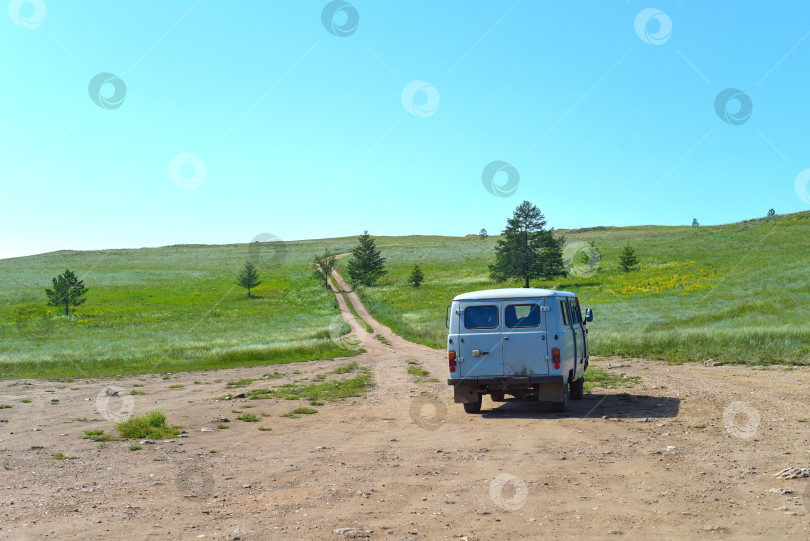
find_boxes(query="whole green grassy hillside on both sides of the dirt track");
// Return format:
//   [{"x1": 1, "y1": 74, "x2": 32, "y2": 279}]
[{"x1": 0, "y1": 209, "x2": 810, "y2": 378}]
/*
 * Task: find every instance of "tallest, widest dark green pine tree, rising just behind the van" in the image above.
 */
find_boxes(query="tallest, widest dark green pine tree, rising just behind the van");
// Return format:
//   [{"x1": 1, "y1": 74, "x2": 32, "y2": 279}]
[{"x1": 489, "y1": 201, "x2": 566, "y2": 287}]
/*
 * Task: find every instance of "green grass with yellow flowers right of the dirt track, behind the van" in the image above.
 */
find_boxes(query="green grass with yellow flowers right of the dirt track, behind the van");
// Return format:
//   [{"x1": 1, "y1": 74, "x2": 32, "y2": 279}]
[{"x1": 350, "y1": 212, "x2": 810, "y2": 364}]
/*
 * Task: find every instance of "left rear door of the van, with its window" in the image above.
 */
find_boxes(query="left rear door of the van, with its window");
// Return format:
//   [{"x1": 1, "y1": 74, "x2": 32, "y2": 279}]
[{"x1": 458, "y1": 301, "x2": 503, "y2": 378}]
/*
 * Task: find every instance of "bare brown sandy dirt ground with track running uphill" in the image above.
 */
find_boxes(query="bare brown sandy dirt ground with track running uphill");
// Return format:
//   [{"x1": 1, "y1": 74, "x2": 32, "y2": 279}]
[{"x1": 0, "y1": 268, "x2": 810, "y2": 540}]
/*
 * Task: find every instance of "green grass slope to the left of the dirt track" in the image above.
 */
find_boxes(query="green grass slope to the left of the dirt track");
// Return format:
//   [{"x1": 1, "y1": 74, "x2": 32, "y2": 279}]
[{"x1": 0, "y1": 239, "x2": 360, "y2": 378}]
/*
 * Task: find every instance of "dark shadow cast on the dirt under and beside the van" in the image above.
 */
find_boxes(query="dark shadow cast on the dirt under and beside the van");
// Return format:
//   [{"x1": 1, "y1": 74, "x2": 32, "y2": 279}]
[{"x1": 481, "y1": 393, "x2": 681, "y2": 419}]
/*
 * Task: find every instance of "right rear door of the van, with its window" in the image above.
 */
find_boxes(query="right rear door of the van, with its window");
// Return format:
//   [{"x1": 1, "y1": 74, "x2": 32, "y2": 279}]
[{"x1": 501, "y1": 299, "x2": 548, "y2": 376}]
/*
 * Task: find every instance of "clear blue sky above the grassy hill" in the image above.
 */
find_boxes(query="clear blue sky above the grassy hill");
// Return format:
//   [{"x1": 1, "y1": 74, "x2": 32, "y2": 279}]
[{"x1": 0, "y1": 0, "x2": 810, "y2": 257}]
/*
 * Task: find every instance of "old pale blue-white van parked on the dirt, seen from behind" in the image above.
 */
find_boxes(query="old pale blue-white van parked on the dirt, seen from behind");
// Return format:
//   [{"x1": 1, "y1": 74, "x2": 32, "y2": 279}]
[{"x1": 447, "y1": 288, "x2": 593, "y2": 413}]
